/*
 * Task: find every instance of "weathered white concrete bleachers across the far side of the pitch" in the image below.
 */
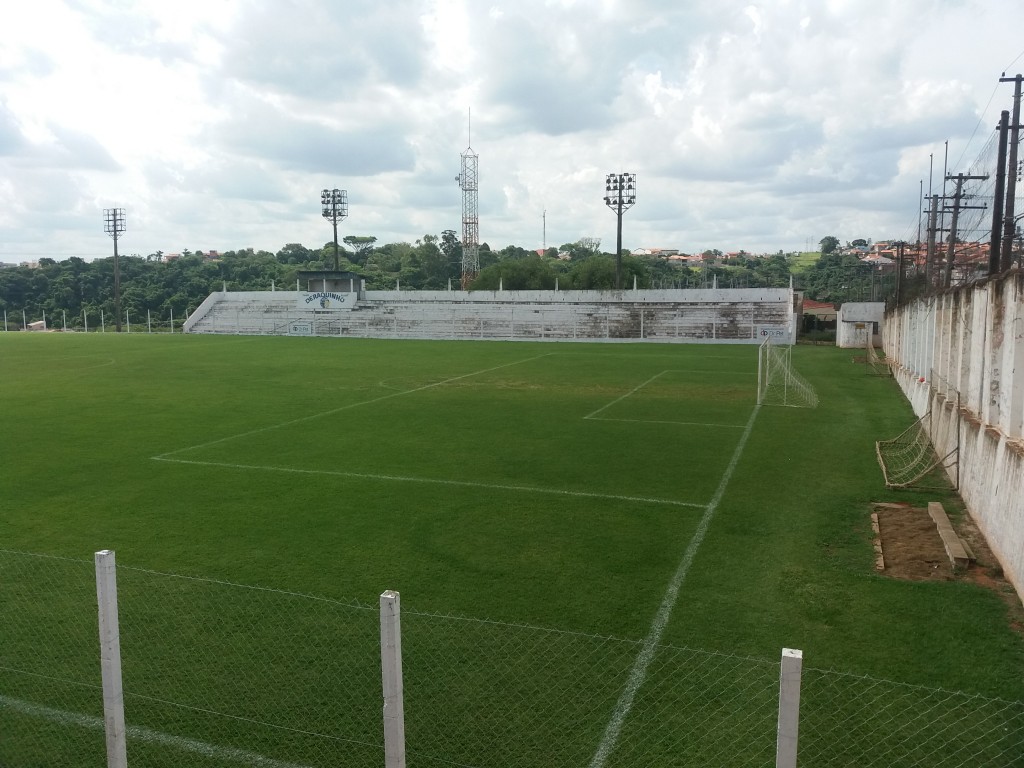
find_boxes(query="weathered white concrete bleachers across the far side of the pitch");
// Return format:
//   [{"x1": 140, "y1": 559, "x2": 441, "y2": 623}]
[{"x1": 186, "y1": 288, "x2": 797, "y2": 344}]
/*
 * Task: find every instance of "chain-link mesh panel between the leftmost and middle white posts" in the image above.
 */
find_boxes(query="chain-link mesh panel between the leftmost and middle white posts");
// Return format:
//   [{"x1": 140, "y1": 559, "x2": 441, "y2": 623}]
[{"x1": 112, "y1": 566, "x2": 383, "y2": 766}]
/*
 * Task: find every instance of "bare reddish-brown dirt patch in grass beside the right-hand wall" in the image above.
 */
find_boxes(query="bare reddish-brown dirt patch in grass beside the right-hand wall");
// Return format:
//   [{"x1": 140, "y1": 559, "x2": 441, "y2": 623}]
[{"x1": 872, "y1": 504, "x2": 1024, "y2": 634}]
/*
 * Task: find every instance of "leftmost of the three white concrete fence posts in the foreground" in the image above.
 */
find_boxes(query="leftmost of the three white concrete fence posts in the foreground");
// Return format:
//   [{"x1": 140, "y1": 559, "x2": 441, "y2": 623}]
[{"x1": 95, "y1": 549, "x2": 128, "y2": 768}]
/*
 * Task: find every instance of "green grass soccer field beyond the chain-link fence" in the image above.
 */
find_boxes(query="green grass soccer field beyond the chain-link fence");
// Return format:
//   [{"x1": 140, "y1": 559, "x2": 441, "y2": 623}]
[{"x1": 0, "y1": 334, "x2": 1024, "y2": 764}]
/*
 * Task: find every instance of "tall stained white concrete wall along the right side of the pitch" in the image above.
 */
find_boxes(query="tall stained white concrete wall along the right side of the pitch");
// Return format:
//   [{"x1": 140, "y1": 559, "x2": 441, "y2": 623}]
[{"x1": 885, "y1": 271, "x2": 1024, "y2": 597}]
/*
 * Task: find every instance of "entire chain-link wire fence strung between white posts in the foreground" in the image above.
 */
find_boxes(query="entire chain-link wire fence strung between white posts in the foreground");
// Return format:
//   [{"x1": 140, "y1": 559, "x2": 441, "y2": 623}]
[{"x1": 0, "y1": 551, "x2": 1024, "y2": 768}]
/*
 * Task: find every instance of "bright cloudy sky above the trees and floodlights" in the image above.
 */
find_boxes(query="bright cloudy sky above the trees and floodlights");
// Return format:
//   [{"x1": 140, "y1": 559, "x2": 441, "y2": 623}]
[{"x1": 0, "y1": 0, "x2": 1024, "y2": 262}]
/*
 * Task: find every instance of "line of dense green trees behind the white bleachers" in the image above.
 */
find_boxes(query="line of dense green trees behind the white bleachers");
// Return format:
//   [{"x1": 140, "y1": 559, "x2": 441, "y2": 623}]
[{"x1": 0, "y1": 229, "x2": 880, "y2": 327}]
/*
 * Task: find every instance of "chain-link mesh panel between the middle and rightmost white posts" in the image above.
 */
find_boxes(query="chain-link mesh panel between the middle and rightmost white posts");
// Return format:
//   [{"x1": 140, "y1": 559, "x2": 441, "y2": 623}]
[{"x1": 402, "y1": 609, "x2": 778, "y2": 768}]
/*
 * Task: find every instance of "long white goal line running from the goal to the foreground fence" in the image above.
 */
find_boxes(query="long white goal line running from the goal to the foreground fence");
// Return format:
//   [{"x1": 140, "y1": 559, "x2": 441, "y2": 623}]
[{"x1": 590, "y1": 406, "x2": 761, "y2": 768}]
